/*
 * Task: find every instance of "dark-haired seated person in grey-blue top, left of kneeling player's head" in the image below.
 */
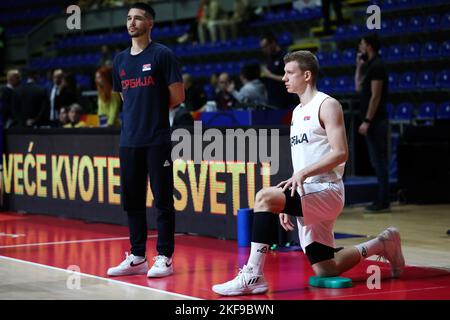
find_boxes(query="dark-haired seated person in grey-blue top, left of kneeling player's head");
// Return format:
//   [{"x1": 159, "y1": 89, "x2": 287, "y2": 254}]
[{"x1": 227, "y1": 65, "x2": 268, "y2": 104}]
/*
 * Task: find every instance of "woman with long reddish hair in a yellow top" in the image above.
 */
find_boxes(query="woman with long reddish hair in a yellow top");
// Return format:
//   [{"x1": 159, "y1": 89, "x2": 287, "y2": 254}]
[{"x1": 95, "y1": 66, "x2": 122, "y2": 127}]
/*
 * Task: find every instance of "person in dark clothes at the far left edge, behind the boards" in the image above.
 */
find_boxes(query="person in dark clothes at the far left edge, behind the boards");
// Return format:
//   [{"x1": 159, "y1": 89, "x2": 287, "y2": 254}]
[{"x1": 0, "y1": 69, "x2": 21, "y2": 129}]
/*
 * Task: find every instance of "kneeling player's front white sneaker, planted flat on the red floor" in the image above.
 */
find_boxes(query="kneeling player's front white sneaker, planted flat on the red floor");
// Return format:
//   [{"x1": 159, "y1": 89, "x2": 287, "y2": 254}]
[{"x1": 212, "y1": 265, "x2": 269, "y2": 296}]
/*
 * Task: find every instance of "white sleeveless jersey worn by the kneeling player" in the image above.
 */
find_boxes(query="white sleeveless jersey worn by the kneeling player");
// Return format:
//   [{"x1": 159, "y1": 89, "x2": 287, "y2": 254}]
[{"x1": 290, "y1": 91, "x2": 345, "y2": 183}]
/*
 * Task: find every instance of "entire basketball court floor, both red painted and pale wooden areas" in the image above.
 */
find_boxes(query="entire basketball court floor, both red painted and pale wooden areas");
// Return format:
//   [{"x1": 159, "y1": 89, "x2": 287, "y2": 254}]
[{"x1": 0, "y1": 205, "x2": 450, "y2": 300}]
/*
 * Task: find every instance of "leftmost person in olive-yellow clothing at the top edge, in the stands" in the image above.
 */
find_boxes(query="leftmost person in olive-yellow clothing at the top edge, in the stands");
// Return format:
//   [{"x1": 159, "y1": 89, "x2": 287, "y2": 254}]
[{"x1": 198, "y1": 0, "x2": 228, "y2": 43}]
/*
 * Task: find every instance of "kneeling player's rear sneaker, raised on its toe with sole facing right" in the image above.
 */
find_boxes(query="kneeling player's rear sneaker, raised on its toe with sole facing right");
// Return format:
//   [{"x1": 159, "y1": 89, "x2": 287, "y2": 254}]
[{"x1": 378, "y1": 227, "x2": 405, "y2": 278}]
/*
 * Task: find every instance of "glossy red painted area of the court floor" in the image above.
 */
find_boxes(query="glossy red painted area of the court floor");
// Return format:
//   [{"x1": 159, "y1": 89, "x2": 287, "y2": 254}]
[{"x1": 0, "y1": 213, "x2": 450, "y2": 300}]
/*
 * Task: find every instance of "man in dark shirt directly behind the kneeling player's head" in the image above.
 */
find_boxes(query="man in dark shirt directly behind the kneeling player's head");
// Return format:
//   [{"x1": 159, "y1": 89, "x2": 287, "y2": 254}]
[{"x1": 260, "y1": 33, "x2": 298, "y2": 109}]
